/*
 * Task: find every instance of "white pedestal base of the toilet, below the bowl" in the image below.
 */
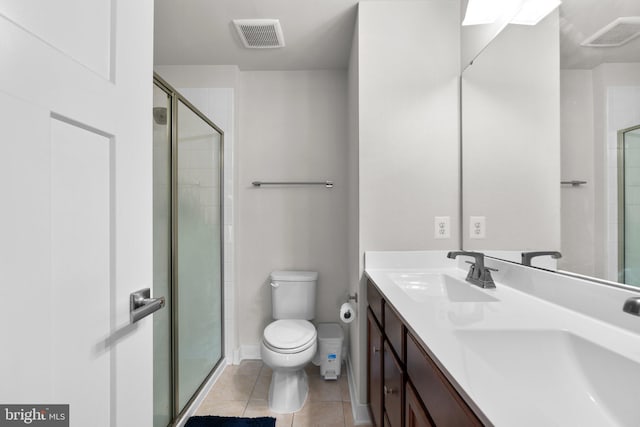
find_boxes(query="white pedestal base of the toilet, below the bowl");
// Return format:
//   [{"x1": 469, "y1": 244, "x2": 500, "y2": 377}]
[{"x1": 269, "y1": 369, "x2": 309, "y2": 414}]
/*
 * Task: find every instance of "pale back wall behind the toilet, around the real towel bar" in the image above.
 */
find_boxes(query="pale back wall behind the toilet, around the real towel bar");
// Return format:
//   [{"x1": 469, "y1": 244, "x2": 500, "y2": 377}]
[{"x1": 236, "y1": 70, "x2": 348, "y2": 357}]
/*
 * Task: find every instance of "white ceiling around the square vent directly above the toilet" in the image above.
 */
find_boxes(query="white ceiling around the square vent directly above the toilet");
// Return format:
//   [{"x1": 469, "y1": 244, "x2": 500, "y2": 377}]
[{"x1": 154, "y1": 0, "x2": 359, "y2": 70}]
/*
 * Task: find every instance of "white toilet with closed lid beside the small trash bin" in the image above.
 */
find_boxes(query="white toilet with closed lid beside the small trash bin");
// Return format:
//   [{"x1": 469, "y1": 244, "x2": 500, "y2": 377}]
[{"x1": 260, "y1": 271, "x2": 318, "y2": 414}]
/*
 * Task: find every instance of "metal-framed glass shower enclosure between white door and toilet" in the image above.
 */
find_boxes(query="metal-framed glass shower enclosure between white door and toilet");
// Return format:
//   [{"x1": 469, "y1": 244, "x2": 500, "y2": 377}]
[{"x1": 153, "y1": 76, "x2": 224, "y2": 427}]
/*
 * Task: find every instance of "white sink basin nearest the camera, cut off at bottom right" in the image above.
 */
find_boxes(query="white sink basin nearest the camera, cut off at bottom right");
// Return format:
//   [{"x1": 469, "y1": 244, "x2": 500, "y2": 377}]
[{"x1": 455, "y1": 330, "x2": 640, "y2": 426}]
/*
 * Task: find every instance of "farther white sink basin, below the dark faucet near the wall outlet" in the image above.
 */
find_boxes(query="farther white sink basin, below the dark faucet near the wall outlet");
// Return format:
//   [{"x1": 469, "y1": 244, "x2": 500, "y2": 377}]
[{"x1": 389, "y1": 273, "x2": 498, "y2": 302}]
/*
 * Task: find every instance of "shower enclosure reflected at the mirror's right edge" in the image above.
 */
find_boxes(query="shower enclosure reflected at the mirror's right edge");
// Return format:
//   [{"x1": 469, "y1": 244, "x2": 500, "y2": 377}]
[{"x1": 618, "y1": 126, "x2": 640, "y2": 286}]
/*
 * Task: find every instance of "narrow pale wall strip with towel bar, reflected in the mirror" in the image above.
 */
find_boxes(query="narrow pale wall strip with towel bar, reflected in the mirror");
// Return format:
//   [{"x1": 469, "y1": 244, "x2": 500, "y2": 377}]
[{"x1": 558, "y1": 70, "x2": 596, "y2": 276}]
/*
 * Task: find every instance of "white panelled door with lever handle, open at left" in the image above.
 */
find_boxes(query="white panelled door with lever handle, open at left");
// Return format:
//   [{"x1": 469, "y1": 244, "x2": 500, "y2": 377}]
[{"x1": 0, "y1": 0, "x2": 153, "y2": 427}]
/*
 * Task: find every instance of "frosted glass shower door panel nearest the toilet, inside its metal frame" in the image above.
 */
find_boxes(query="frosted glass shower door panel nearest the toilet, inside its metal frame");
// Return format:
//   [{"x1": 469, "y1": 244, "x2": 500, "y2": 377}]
[{"x1": 175, "y1": 100, "x2": 222, "y2": 412}]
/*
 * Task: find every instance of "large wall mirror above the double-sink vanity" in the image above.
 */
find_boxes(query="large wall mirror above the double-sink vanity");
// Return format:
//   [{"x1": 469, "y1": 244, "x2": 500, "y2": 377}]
[{"x1": 461, "y1": 0, "x2": 640, "y2": 285}]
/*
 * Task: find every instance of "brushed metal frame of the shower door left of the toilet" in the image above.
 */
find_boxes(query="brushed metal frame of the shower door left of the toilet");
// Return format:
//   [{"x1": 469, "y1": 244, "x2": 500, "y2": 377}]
[{"x1": 153, "y1": 72, "x2": 226, "y2": 426}]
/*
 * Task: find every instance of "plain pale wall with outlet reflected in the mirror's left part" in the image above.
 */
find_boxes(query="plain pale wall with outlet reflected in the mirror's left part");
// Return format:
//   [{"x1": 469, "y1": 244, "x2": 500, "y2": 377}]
[{"x1": 462, "y1": 11, "x2": 560, "y2": 250}]
